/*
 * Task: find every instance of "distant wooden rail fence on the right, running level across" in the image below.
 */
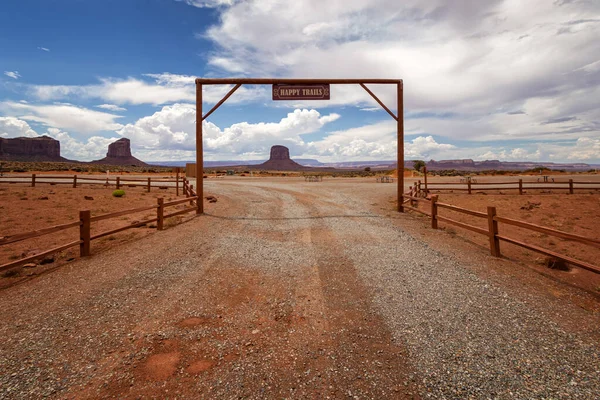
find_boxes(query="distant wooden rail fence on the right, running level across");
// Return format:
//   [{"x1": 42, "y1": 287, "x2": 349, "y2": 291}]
[{"x1": 416, "y1": 179, "x2": 600, "y2": 194}]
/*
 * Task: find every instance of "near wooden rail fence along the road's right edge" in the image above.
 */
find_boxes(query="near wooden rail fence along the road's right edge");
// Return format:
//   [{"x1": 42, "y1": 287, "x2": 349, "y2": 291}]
[{"x1": 403, "y1": 186, "x2": 600, "y2": 273}]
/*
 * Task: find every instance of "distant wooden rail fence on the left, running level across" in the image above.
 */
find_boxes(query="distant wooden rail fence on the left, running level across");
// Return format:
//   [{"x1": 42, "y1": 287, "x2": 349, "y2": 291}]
[{"x1": 0, "y1": 172, "x2": 185, "y2": 196}]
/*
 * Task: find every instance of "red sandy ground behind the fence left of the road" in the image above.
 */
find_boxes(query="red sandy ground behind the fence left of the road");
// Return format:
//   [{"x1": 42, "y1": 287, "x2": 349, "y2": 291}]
[{"x1": 0, "y1": 181, "x2": 191, "y2": 288}]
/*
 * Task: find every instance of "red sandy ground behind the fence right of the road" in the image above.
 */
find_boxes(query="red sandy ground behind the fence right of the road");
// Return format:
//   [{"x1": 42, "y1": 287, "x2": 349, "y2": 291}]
[{"x1": 406, "y1": 193, "x2": 600, "y2": 295}]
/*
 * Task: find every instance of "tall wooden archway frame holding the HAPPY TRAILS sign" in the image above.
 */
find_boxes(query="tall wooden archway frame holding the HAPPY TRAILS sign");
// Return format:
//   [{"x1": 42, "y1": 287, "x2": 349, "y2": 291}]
[{"x1": 196, "y1": 78, "x2": 404, "y2": 214}]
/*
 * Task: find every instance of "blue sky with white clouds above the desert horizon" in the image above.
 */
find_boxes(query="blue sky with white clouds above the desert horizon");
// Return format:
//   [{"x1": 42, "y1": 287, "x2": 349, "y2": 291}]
[{"x1": 0, "y1": 0, "x2": 600, "y2": 163}]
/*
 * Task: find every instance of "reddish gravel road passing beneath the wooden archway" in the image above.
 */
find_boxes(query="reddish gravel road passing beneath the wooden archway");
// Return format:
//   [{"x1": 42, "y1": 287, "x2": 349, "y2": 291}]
[{"x1": 0, "y1": 179, "x2": 600, "y2": 399}]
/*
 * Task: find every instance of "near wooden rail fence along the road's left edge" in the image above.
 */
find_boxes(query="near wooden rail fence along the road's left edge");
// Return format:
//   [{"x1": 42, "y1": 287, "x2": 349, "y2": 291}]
[{"x1": 0, "y1": 178, "x2": 202, "y2": 271}]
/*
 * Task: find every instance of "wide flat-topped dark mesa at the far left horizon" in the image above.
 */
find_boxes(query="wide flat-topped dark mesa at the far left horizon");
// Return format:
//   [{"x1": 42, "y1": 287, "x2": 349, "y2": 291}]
[{"x1": 0, "y1": 136, "x2": 69, "y2": 162}]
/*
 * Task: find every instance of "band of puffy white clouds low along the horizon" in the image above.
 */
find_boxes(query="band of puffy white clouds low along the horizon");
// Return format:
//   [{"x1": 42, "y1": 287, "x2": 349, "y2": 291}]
[{"x1": 0, "y1": 110, "x2": 600, "y2": 163}]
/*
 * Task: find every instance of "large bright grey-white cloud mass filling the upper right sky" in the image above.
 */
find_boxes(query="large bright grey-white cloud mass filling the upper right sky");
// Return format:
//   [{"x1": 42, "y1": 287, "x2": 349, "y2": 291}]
[{"x1": 193, "y1": 0, "x2": 600, "y2": 144}]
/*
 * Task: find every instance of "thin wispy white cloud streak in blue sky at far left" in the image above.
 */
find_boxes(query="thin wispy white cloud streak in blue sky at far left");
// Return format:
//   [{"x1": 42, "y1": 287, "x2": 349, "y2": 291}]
[{"x1": 0, "y1": 101, "x2": 123, "y2": 134}]
